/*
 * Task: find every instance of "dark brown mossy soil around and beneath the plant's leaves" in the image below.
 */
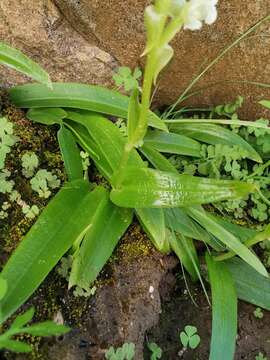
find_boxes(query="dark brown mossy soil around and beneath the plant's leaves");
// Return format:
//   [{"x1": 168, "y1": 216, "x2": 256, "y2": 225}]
[{"x1": 0, "y1": 93, "x2": 270, "y2": 360}]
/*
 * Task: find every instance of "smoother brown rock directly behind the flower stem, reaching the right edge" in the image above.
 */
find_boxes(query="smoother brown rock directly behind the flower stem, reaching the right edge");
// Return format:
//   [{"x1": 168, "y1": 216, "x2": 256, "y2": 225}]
[{"x1": 54, "y1": 0, "x2": 270, "y2": 119}]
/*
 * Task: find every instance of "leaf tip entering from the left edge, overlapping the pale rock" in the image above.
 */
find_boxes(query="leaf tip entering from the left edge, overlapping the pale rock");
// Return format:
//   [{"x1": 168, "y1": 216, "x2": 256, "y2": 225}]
[{"x1": 0, "y1": 42, "x2": 52, "y2": 88}]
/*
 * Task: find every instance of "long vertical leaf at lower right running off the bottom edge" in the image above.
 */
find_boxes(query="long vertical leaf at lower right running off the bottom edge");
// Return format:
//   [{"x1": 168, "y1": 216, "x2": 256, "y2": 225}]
[{"x1": 206, "y1": 253, "x2": 237, "y2": 360}]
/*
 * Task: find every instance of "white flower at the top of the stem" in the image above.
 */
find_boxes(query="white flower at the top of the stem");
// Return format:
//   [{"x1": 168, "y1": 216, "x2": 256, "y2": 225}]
[{"x1": 184, "y1": 0, "x2": 218, "y2": 30}]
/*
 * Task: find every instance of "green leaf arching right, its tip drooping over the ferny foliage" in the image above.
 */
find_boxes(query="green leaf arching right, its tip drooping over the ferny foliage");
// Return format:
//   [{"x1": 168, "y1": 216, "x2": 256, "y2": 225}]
[{"x1": 170, "y1": 123, "x2": 262, "y2": 163}]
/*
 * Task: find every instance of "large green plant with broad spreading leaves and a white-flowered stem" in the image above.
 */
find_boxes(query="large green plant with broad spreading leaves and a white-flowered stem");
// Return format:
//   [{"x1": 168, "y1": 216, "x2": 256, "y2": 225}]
[{"x1": 1, "y1": 0, "x2": 270, "y2": 360}]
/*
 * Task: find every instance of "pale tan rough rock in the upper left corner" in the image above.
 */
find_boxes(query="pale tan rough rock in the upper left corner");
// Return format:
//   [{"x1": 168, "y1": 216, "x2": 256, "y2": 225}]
[{"x1": 0, "y1": 0, "x2": 116, "y2": 86}]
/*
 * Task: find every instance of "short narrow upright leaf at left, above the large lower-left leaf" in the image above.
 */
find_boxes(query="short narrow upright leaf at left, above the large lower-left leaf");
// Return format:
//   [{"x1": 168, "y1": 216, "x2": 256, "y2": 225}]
[{"x1": 57, "y1": 126, "x2": 83, "y2": 181}]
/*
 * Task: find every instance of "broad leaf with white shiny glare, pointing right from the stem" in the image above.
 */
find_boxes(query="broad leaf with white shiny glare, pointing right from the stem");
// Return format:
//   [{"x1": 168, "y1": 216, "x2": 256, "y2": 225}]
[{"x1": 111, "y1": 168, "x2": 254, "y2": 208}]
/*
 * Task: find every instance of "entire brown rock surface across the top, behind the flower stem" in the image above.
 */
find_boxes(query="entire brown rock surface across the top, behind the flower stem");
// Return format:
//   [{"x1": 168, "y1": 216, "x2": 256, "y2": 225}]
[{"x1": 0, "y1": 0, "x2": 270, "y2": 119}]
